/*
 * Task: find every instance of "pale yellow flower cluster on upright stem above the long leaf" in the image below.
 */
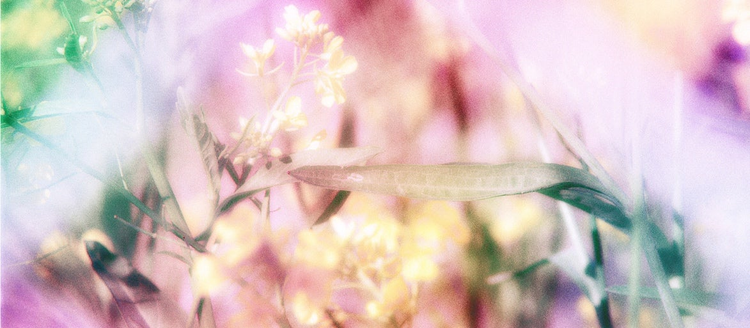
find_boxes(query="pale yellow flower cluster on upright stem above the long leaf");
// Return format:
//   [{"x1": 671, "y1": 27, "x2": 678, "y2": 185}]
[{"x1": 228, "y1": 5, "x2": 357, "y2": 164}]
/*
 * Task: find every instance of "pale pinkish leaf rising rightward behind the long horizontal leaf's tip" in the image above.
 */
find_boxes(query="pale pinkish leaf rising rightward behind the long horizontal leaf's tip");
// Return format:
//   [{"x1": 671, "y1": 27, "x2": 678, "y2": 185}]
[{"x1": 218, "y1": 146, "x2": 380, "y2": 213}]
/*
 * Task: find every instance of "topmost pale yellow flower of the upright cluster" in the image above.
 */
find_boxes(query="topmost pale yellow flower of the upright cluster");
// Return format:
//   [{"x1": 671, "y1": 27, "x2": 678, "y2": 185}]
[{"x1": 276, "y1": 5, "x2": 328, "y2": 47}]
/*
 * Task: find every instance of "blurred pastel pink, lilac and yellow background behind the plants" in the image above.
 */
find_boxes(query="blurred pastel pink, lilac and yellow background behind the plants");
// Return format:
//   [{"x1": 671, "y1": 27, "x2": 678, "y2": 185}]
[{"x1": 1, "y1": 0, "x2": 750, "y2": 327}]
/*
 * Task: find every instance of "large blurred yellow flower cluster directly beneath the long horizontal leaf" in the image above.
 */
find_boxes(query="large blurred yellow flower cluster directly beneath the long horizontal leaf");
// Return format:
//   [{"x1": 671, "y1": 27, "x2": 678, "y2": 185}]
[{"x1": 291, "y1": 198, "x2": 469, "y2": 325}]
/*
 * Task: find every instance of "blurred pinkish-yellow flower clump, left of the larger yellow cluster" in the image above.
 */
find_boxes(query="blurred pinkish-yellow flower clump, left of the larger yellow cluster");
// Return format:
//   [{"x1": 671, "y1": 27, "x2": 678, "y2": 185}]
[{"x1": 191, "y1": 204, "x2": 289, "y2": 327}]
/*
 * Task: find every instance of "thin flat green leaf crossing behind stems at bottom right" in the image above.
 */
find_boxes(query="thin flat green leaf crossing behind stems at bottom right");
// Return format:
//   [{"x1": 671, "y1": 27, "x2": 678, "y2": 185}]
[{"x1": 607, "y1": 286, "x2": 732, "y2": 309}]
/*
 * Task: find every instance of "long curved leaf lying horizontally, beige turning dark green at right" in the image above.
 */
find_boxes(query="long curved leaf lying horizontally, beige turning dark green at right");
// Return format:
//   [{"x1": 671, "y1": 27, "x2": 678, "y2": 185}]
[{"x1": 289, "y1": 163, "x2": 630, "y2": 231}]
